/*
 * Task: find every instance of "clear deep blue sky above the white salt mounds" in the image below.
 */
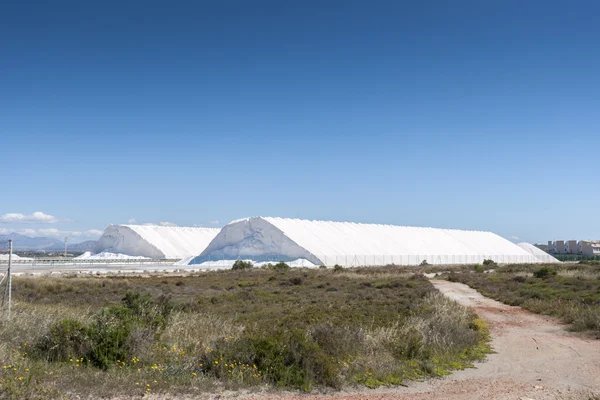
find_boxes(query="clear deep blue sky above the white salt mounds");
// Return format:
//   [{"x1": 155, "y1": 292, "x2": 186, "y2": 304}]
[{"x1": 0, "y1": 0, "x2": 600, "y2": 242}]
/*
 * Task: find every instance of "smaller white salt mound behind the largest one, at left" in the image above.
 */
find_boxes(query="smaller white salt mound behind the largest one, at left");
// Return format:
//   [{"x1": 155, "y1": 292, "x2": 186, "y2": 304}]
[{"x1": 95, "y1": 225, "x2": 220, "y2": 259}]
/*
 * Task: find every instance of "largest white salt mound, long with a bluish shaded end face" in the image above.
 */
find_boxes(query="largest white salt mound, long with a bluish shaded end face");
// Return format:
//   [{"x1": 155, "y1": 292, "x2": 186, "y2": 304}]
[{"x1": 192, "y1": 217, "x2": 552, "y2": 266}]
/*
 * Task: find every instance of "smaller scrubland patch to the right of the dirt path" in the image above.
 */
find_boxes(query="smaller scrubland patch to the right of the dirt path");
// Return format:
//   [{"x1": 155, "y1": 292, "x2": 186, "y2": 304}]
[{"x1": 444, "y1": 261, "x2": 600, "y2": 339}]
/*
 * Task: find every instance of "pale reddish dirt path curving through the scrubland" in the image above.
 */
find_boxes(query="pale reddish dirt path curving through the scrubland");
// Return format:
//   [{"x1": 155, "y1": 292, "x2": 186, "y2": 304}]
[{"x1": 230, "y1": 280, "x2": 600, "y2": 400}]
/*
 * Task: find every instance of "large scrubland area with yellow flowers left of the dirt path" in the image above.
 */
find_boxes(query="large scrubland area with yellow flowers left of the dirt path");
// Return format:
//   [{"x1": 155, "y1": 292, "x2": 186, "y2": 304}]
[{"x1": 0, "y1": 265, "x2": 490, "y2": 399}]
